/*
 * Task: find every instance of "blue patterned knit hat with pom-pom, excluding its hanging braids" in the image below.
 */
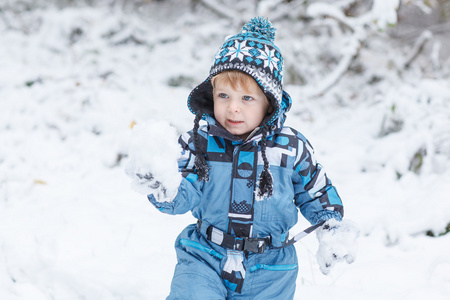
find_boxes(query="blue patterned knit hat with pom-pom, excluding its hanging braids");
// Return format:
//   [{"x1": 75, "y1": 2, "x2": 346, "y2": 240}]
[{"x1": 188, "y1": 17, "x2": 284, "y2": 125}]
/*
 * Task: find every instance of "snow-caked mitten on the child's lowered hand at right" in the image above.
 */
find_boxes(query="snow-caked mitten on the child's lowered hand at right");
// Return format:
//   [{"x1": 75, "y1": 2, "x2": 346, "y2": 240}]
[{"x1": 316, "y1": 219, "x2": 359, "y2": 275}]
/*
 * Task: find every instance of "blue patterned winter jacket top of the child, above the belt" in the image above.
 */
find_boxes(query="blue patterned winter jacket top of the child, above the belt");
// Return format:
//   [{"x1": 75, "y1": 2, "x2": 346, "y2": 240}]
[{"x1": 148, "y1": 94, "x2": 343, "y2": 247}]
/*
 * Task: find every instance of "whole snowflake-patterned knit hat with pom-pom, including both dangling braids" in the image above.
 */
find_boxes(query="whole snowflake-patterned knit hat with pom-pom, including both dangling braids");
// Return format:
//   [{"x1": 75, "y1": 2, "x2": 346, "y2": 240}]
[{"x1": 188, "y1": 17, "x2": 290, "y2": 197}]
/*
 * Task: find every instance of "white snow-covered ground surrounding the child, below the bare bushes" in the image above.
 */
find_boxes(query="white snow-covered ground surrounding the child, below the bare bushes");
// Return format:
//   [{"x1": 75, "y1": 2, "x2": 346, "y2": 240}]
[{"x1": 0, "y1": 2, "x2": 450, "y2": 300}]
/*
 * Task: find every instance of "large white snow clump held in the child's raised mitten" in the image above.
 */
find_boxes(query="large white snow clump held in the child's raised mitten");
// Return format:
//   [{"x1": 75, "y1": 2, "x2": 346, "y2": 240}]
[{"x1": 126, "y1": 120, "x2": 181, "y2": 202}]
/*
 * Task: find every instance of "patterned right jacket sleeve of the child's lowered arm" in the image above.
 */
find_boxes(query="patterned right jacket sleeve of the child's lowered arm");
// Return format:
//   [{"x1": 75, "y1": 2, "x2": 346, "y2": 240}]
[{"x1": 293, "y1": 136, "x2": 344, "y2": 225}]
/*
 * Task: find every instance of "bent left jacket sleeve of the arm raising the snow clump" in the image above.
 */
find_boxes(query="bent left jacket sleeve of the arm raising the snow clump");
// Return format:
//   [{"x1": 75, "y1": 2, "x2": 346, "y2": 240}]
[{"x1": 147, "y1": 131, "x2": 204, "y2": 215}]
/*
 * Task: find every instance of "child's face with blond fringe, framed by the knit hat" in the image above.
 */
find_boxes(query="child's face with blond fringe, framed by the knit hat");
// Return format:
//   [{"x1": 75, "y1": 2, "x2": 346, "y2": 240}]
[{"x1": 213, "y1": 80, "x2": 269, "y2": 139}]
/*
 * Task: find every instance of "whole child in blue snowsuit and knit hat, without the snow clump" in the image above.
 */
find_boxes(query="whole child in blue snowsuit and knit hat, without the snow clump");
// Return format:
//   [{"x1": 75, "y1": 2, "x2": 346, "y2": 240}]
[{"x1": 132, "y1": 17, "x2": 354, "y2": 300}]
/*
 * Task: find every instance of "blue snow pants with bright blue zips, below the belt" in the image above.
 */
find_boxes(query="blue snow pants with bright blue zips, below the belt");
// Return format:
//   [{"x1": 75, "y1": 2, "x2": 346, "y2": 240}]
[{"x1": 167, "y1": 224, "x2": 298, "y2": 300}]
